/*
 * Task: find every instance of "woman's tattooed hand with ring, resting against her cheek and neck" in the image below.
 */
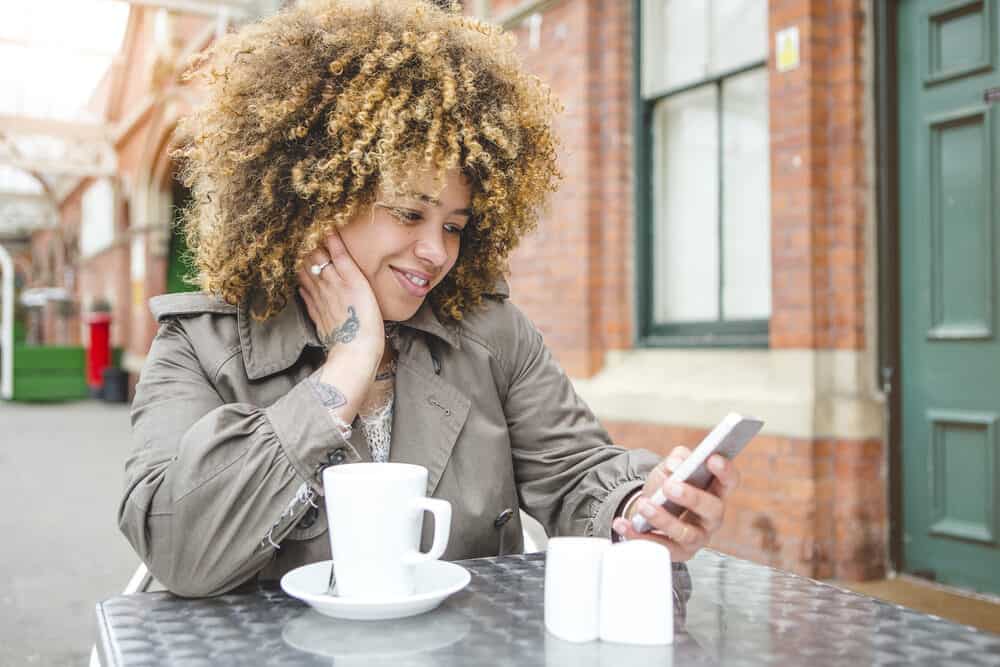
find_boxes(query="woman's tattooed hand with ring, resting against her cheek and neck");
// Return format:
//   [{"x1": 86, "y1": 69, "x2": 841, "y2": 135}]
[{"x1": 298, "y1": 231, "x2": 385, "y2": 376}]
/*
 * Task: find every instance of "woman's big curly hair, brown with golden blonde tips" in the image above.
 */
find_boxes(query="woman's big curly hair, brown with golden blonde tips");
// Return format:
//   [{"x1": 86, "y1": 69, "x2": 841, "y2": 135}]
[{"x1": 175, "y1": 0, "x2": 562, "y2": 321}]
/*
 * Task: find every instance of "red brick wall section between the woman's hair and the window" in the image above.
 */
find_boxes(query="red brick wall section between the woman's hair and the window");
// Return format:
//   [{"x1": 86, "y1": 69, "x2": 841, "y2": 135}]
[{"x1": 504, "y1": 0, "x2": 633, "y2": 377}]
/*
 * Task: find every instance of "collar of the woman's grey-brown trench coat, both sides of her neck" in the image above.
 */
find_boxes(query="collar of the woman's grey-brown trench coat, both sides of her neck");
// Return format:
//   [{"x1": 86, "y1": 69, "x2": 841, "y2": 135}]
[{"x1": 236, "y1": 296, "x2": 460, "y2": 380}]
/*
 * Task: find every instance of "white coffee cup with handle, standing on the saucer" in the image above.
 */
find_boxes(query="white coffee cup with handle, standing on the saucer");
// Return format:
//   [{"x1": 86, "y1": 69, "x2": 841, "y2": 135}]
[{"x1": 323, "y1": 463, "x2": 451, "y2": 600}]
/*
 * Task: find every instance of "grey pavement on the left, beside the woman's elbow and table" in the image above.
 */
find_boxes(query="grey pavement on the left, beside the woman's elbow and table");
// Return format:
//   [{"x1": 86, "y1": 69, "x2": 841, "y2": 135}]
[{"x1": 0, "y1": 401, "x2": 139, "y2": 667}]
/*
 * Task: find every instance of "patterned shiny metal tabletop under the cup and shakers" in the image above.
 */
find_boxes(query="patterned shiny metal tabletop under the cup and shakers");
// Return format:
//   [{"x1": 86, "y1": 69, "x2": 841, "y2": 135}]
[{"x1": 97, "y1": 550, "x2": 1000, "y2": 667}]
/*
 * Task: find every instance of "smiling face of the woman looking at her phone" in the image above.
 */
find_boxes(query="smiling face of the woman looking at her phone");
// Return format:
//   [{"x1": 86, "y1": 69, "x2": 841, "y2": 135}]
[{"x1": 340, "y1": 170, "x2": 472, "y2": 320}]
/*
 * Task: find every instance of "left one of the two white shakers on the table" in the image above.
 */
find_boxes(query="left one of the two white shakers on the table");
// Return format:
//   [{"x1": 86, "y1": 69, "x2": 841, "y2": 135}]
[{"x1": 545, "y1": 537, "x2": 611, "y2": 642}]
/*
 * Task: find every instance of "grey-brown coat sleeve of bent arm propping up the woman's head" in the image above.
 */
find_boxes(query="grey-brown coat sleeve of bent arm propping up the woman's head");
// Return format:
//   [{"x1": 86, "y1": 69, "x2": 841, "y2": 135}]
[{"x1": 118, "y1": 319, "x2": 356, "y2": 597}]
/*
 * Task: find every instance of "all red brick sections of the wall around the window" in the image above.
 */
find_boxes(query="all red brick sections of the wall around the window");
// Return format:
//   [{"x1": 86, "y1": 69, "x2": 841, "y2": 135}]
[{"x1": 500, "y1": 0, "x2": 887, "y2": 579}]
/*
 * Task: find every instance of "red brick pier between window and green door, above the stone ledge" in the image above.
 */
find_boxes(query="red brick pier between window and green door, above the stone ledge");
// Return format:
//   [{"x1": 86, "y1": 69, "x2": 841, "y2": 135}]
[{"x1": 769, "y1": 0, "x2": 868, "y2": 349}]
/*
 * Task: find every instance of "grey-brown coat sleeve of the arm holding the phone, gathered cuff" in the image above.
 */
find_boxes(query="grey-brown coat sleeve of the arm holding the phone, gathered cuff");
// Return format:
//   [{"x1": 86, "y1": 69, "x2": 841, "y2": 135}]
[{"x1": 501, "y1": 304, "x2": 659, "y2": 537}]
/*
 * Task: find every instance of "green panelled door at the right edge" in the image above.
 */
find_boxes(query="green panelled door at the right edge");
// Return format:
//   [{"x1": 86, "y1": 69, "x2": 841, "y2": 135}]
[{"x1": 897, "y1": 0, "x2": 1000, "y2": 593}]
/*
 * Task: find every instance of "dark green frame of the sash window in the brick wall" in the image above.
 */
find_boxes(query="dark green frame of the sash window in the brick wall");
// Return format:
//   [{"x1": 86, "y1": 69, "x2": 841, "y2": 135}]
[{"x1": 632, "y1": 0, "x2": 773, "y2": 348}]
